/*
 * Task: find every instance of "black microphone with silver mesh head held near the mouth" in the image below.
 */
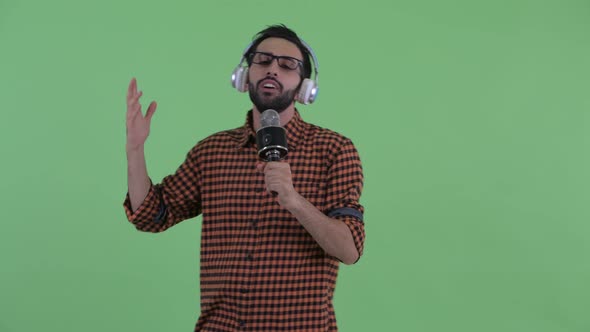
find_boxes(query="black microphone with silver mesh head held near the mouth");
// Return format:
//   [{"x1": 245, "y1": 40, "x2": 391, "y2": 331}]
[{"x1": 256, "y1": 109, "x2": 287, "y2": 161}]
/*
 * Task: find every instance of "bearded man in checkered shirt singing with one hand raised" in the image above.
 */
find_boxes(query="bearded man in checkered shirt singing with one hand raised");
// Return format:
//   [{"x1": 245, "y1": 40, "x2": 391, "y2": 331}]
[{"x1": 124, "y1": 26, "x2": 365, "y2": 331}]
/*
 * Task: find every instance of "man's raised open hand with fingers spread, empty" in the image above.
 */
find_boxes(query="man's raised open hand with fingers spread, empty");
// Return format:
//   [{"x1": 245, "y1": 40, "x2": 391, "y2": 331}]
[{"x1": 127, "y1": 78, "x2": 157, "y2": 151}]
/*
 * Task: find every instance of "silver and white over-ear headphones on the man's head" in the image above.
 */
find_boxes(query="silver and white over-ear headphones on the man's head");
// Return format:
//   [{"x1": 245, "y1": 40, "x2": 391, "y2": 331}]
[{"x1": 231, "y1": 39, "x2": 319, "y2": 105}]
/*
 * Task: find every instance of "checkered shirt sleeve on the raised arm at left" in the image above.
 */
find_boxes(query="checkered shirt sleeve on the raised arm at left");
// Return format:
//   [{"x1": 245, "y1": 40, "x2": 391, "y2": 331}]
[{"x1": 123, "y1": 149, "x2": 201, "y2": 233}]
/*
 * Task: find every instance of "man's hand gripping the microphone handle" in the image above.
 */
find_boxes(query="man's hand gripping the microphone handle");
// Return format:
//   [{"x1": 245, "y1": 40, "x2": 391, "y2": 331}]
[{"x1": 256, "y1": 161, "x2": 299, "y2": 209}]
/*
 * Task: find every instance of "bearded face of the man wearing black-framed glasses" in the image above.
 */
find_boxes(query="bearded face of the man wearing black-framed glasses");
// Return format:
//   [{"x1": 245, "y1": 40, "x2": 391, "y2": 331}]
[{"x1": 248, "y1": 38, "x2": 303, "y2": 113}]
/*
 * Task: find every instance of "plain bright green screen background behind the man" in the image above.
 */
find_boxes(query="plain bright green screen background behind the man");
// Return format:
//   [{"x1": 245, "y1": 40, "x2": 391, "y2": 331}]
[{"x1": 0, "y1": 0, "x2": 590, "y2": 332}]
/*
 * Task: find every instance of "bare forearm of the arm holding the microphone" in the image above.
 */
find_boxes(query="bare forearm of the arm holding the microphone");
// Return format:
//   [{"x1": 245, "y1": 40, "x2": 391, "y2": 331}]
[{"x1": 287, "y1": 194, "x2": 359, "y2": 264}]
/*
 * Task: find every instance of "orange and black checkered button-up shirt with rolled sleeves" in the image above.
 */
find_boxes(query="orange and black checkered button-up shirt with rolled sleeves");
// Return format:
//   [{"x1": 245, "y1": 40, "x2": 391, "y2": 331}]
[{"x1": 124, "y1": 111, "x2": 365, "y2": 332}]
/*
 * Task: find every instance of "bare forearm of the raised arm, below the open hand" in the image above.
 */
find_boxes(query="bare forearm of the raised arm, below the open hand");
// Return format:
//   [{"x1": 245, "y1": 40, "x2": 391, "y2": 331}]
[{"x1": 127, "y1": 146, "x2": 151, "y2": 212}]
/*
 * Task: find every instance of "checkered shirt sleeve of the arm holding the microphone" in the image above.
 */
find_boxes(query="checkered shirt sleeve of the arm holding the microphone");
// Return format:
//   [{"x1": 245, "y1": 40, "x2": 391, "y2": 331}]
[{"x1": 325, "y1": 139, "x2": 365, "y2": 258}]
